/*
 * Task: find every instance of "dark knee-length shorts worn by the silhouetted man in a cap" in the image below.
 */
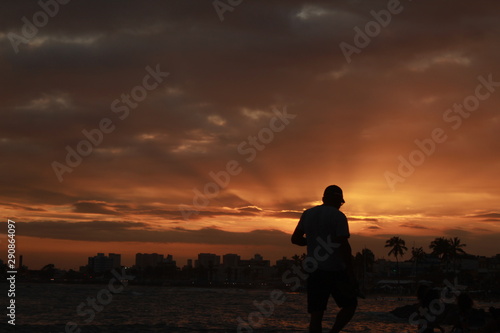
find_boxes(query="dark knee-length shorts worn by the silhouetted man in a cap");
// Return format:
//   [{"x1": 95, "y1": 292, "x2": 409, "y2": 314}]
[{"x1": 307, "y1": 270, "x2": 358, "y2": 313}]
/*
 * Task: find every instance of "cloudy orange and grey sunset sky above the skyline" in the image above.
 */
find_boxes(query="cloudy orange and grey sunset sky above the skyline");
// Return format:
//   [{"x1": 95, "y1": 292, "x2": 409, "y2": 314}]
[{"x1": 0, "y1": 0, "x2": 500, "y2": 269}]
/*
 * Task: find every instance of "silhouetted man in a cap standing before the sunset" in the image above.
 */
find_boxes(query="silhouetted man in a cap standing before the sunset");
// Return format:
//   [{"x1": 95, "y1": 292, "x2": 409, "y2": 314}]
[{"x1": 292, "y1": 185, "x2": 358, "y2": 333}]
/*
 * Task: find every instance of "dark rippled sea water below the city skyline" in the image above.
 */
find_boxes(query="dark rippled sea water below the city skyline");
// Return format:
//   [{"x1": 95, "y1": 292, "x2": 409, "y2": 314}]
[{"x1": 0, "y1": 284, "x2": 498, "y2": 333}]
